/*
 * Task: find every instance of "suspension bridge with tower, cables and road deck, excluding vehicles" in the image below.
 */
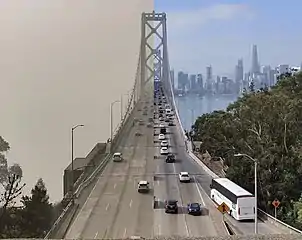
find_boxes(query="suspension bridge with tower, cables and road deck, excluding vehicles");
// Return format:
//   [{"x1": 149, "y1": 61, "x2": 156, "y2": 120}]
[{"x1": 40, "y1": 12, "x2": 301, "y2": 239}]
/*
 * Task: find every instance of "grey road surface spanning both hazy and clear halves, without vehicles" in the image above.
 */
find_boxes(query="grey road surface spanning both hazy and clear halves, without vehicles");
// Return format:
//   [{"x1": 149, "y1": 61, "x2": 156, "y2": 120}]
[{"x1": 65, "y1": 88, "x2": 282, "y2": 239}]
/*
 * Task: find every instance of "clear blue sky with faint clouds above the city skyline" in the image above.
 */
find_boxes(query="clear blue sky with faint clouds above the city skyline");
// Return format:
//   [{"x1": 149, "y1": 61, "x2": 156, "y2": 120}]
[{"x1": 155, "y1": 0, "x2": 302, "y2": 77}]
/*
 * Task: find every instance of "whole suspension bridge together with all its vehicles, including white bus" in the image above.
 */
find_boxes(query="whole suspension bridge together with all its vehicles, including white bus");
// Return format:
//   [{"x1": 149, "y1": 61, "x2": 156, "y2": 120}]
[{"x1": 43, "y1": 12, "x2": 300, "y2": 239}]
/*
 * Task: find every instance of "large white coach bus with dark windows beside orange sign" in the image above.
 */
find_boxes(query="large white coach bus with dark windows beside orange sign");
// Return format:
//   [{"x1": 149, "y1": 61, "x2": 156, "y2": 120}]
[{"x1": 210, "y1": 178, "x2": 255, "y2": 221}]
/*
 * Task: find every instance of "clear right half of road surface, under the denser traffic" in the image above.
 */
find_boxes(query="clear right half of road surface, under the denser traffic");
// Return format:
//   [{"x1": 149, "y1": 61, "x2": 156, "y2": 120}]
[{"x1": 154, "y1": 115, "x2": 227, "y2": 237}]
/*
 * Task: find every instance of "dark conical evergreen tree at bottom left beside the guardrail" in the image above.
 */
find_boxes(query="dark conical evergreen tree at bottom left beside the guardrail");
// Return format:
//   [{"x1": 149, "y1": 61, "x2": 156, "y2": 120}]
[{"x1": 21, "y1": 178, "x2": 53, "y2": 238}]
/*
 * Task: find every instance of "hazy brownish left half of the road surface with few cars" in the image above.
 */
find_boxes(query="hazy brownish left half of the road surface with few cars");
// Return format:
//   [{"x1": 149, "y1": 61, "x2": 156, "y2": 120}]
[{"x1": 65, "y1": 93, "x2": 154, "y2": 239}]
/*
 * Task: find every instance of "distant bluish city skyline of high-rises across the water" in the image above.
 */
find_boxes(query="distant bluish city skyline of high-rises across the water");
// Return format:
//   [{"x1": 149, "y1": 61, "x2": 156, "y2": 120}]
[{"x1": 171, "y1": 44, "x2": 302, "y2": 96}]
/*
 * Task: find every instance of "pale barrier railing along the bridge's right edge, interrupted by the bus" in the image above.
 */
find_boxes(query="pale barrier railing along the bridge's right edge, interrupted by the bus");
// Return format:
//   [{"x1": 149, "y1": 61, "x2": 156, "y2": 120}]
[{"x1": 165, "y1": 66, "x2": 302, "y2": 234}]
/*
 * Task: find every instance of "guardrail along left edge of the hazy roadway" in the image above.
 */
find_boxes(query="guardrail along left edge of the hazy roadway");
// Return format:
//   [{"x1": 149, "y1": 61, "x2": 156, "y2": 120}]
[{"x1": 44, "y1": 154, "x2": 111, "y2": 239}]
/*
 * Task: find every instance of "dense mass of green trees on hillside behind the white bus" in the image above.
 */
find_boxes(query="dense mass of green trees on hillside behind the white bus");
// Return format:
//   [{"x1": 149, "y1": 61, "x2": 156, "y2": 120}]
[{"x1": 193, "y1": 74, "x2": 302, "y2": 226}]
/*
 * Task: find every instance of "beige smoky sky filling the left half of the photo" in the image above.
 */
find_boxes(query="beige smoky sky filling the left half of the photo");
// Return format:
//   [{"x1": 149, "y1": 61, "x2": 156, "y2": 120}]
[{"x1": 0, "y1": 0, "x2": 153, "y2": 201}]
